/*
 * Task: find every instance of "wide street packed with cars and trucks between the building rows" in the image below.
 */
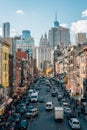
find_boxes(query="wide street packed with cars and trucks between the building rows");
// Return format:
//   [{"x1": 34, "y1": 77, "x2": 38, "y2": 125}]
[{"x1": 0, "y1": 78, "x2": 87, "y2": 130}]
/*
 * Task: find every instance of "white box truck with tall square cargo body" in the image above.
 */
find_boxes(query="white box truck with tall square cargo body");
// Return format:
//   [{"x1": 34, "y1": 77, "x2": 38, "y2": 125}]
[{"x1": 54, "y1": 107, "x2": 64, "y2": 120}]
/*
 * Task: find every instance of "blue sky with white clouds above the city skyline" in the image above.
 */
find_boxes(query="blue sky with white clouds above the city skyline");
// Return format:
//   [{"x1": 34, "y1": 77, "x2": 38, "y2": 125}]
[{"x1": 0, "y1": 0, "x2": 87, "y2": 46}]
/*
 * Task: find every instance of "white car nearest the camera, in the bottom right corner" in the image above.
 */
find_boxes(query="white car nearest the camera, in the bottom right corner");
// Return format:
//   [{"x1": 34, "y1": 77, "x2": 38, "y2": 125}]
[{"x1": 69, "y1": 118, "x2": 80, "y2": 129}]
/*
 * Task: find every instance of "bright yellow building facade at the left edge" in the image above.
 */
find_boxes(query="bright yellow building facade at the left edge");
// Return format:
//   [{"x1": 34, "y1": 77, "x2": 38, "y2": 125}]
[{"x1": 2, "y1": 41, "x2": 9, "y2": 97}]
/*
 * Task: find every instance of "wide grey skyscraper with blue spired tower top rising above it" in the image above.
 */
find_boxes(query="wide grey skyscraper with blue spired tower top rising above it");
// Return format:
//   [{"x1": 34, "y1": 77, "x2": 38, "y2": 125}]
[{"x1": 48, "y1": 16, "x2": 70, "y2": 49}]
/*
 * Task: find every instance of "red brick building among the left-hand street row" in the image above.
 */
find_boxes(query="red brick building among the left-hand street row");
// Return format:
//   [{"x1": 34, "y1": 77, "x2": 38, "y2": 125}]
[{"x1": 16, "y1": 49, "x2": 28, "y2": 87}]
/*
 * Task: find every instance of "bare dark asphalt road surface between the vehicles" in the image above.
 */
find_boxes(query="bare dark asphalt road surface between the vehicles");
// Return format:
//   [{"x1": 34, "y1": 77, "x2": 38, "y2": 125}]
[{"x1": 27, "y1": 79, "x2": 87, "y2": 130}]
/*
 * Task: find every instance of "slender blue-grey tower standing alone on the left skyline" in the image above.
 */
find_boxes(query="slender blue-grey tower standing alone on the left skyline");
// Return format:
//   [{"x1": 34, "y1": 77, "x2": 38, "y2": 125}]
[{"x1": 3, "y1": 22, "x2": 10, "y2": 38}]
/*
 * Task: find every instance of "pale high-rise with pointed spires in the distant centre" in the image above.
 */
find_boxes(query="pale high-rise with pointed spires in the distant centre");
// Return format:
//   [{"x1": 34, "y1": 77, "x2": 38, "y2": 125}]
[{"x1": 36, "y1": 33, "x2": 52, "y2": 72}]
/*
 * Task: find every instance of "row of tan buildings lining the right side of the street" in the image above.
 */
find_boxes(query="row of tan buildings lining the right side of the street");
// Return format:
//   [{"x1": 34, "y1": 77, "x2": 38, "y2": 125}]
[{"x1": 56, "y1": 42, "x2": 87, "y2": 100}]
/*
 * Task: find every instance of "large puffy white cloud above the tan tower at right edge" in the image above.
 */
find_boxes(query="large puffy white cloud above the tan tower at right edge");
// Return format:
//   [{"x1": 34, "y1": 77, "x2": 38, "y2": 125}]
[{"x1": 71, "y1": 20, "x2": 87, "y2": 33}]
